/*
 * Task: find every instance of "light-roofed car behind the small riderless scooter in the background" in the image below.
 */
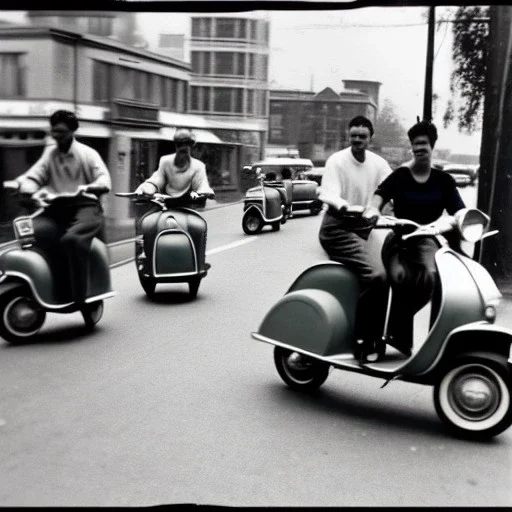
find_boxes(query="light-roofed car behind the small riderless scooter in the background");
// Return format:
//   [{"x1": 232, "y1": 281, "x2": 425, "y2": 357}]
[{"x1": 246, "y1": 157, "x2": 322, "y2": 215}]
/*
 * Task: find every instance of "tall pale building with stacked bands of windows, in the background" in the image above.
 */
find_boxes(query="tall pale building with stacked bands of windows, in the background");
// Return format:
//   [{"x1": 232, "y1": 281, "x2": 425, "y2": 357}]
[{"x1": 189, "y1": 13, "x2": 270, "y2": 185}]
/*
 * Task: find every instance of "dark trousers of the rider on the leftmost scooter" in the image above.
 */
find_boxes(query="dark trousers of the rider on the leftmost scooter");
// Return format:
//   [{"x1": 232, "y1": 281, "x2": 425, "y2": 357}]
[{"x1": 34, "y1": 203, "x2": 103, "y2": 303}]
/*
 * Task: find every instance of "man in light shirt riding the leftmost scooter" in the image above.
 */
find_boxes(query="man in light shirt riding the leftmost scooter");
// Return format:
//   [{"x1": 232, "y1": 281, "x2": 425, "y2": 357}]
[{"x1": 16, "y1": 110, "x2": 111, "y2": 304}]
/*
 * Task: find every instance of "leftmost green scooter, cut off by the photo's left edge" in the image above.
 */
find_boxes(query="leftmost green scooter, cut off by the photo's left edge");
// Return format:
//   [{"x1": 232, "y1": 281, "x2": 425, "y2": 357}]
[{"x1": 0, "y1": 181, "x2": 115, "y2": 344}]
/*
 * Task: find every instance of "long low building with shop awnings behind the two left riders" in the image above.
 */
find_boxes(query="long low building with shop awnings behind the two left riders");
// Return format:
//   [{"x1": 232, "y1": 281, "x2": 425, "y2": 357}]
[{"x1": 0, "y1": 11, "x2": 259, "y2": 231}]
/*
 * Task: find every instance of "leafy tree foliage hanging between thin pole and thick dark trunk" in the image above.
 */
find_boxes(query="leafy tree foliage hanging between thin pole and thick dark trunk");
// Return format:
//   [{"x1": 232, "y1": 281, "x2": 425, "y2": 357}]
[{"x1": 443, "y1": 6, "x2": 489, "y2": 134}]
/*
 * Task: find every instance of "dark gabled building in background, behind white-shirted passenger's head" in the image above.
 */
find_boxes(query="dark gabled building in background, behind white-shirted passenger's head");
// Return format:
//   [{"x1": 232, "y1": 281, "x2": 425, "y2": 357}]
[{"x1": 268, "y1": 80, "x2": 380, "y2": 164}]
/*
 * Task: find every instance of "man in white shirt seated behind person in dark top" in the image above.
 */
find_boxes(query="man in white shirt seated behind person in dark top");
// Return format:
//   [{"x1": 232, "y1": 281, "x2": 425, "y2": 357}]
[{"x1": 319, "y1": 116, "x2": 392, "y2": 359}]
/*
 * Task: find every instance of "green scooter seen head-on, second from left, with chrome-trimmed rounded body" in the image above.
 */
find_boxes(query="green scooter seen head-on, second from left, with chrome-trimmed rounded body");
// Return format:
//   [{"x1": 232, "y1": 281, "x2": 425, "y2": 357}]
[{"x1": 116, "y1": 192, "x2": 213, "y2": 299}]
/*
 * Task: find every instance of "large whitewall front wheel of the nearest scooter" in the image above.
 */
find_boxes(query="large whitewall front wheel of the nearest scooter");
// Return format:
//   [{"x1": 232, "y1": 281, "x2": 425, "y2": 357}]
[{"x1": 434, "y1": 356, "x2": 512, "y2": 440}]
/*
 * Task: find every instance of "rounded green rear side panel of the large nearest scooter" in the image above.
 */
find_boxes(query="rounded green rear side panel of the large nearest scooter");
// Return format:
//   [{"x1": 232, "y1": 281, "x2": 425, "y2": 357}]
[{"x1": 258, "y1": 288, "x2": 353, "y2": 356}]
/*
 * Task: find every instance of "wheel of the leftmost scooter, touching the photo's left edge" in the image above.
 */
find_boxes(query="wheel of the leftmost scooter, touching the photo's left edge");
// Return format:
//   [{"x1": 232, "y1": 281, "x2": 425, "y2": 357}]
[{"x1": 0, "y1": 287, "x2": 46, "y2": 344}]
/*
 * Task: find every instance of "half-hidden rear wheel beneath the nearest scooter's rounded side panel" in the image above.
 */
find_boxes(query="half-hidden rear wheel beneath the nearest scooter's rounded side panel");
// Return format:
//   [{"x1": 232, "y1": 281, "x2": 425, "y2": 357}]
[{"x1": 274, "y1": 346, "x2": 331, "y2": 391}]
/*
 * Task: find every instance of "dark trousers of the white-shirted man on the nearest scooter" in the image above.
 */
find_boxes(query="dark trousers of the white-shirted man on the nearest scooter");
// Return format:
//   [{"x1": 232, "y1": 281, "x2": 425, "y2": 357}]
[{"x1": 319, "y1": 213, "x2": 388, "y2": 342}]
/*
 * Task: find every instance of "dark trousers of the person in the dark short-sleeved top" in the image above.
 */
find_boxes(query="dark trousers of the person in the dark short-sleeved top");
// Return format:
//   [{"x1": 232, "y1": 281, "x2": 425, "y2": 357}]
[{"x1": 383, "y1": 234, "x2": 439, "y2": 349}]
